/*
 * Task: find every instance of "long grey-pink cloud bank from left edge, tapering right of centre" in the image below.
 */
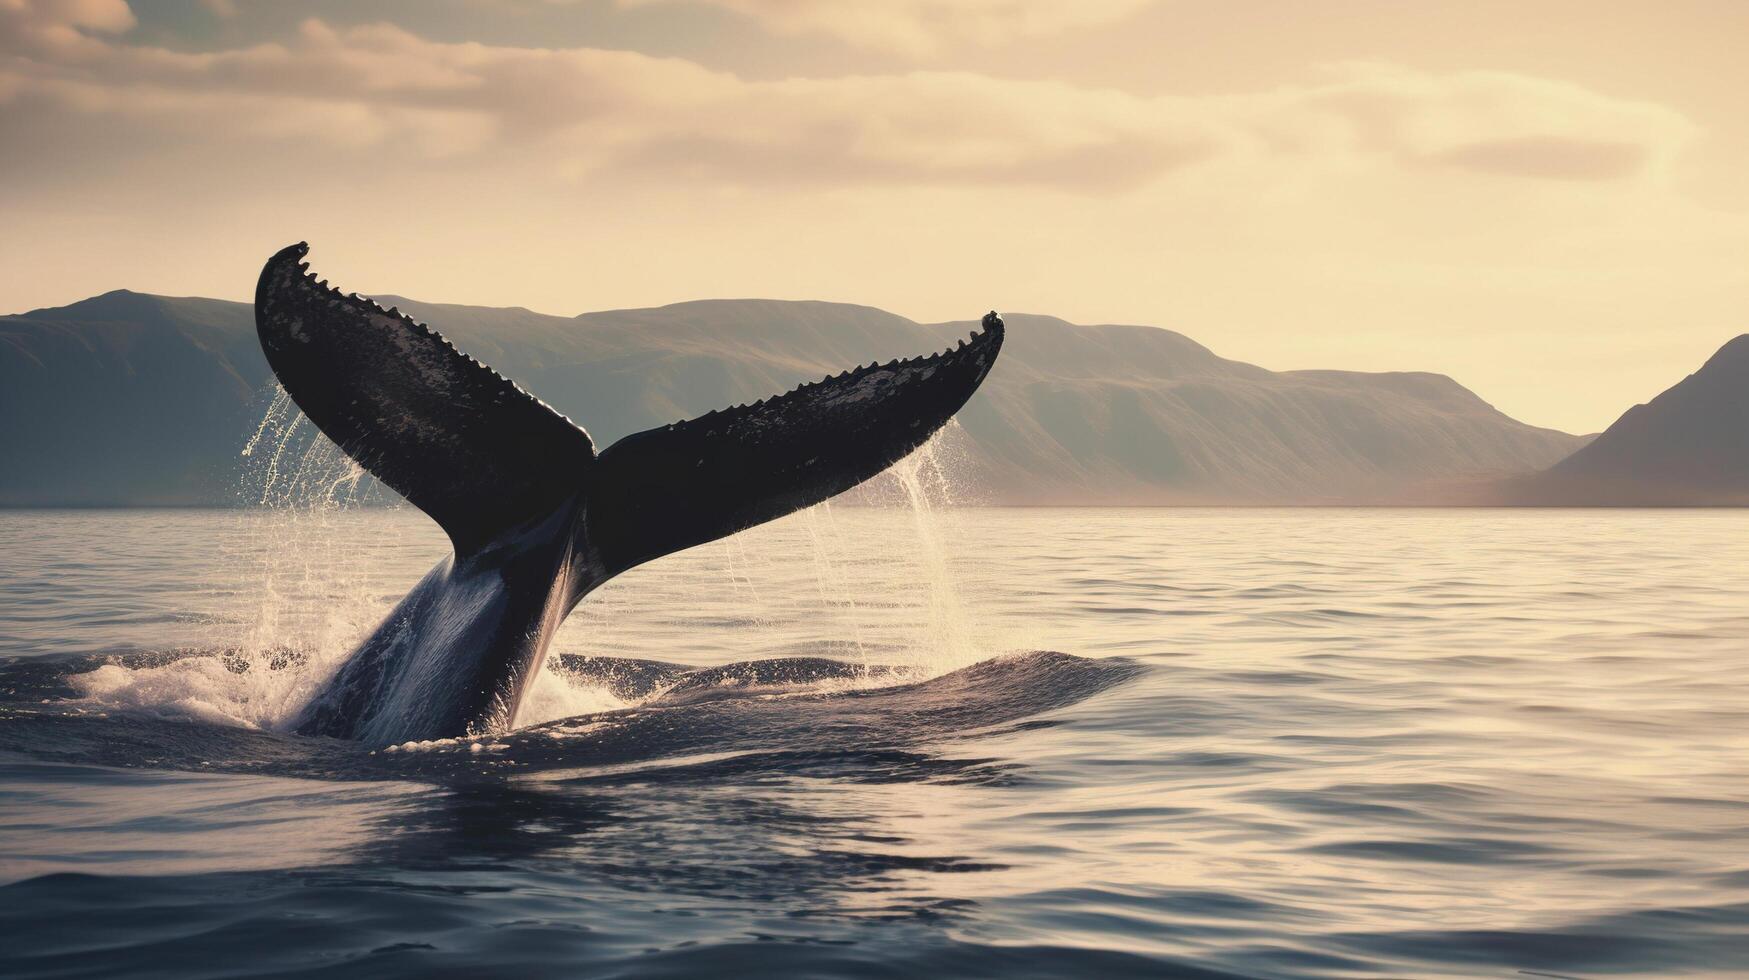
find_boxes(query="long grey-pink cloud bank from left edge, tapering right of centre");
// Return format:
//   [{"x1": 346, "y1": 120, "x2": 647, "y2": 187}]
[{"x1": 0, "y1": 21, "x2": 1216, "y2": 191}]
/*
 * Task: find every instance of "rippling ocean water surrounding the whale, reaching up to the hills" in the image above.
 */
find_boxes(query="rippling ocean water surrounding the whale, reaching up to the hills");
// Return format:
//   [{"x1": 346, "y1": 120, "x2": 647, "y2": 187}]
[{"x1": 0, "y1": 506, "x2": 1749, "y2": 978}]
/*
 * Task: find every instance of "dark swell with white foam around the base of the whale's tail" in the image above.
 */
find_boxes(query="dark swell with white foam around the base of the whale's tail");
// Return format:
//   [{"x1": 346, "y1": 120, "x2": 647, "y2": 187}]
[{"x1": 0, "y1": 649, "x2": 1140, "y2": 779}]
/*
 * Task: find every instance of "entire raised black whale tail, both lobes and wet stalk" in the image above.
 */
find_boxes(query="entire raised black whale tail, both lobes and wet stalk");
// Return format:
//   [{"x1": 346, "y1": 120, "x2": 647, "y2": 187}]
[{"x1": 255, "y1": 243, "x2": 1002, "y2": 742}]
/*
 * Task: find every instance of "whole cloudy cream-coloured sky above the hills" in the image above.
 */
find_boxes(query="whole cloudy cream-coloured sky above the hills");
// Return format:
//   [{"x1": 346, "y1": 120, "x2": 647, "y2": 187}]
[{"x1": 0, "y1": 0, "x2": 1749, "y2": 432}]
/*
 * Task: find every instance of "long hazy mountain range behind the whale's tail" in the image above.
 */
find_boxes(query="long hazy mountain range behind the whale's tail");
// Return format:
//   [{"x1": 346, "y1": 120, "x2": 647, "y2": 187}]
[{"x1": 0, "y1": 291, "x2": 1583, "y2": 506}]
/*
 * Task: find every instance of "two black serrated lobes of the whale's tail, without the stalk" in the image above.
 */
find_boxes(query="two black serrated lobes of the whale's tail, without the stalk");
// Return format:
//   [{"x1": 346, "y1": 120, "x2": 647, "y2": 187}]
[{"x1": 255, "y1": 243, "x2": 1002, "y2": 576}]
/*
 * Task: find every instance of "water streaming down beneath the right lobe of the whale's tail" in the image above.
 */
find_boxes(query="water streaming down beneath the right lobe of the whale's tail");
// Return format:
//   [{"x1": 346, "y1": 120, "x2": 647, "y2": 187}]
[{"x1": 535, "y1": 425, "x2": 1030, "y2": 725}]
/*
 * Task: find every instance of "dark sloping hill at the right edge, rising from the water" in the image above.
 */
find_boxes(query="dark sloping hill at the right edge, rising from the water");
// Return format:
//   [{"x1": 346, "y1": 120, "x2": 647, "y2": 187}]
[{"x1": 1490, "y1": 334, "x2": 1749, "y2": 506}]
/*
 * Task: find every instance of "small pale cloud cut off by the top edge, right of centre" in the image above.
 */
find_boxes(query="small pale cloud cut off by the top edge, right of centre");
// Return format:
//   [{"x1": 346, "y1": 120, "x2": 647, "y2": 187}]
[{"x1": 608, "y1": 0, "x2": 1154, "y2": 58}]
